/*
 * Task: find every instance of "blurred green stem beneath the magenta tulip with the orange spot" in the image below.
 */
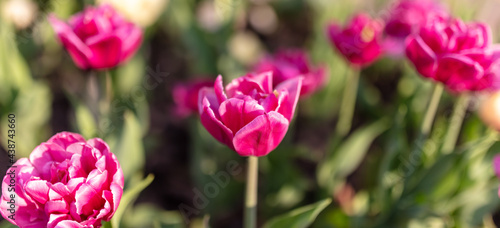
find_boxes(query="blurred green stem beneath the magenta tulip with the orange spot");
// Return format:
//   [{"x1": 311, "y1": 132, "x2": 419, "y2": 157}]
[{"x1": 335, "y1": 68, "x2": 361, "y2": 137}]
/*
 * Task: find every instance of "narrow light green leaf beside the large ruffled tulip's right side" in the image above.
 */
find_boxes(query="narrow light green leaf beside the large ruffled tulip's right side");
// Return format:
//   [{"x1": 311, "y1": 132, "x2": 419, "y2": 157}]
[{"x1": 111, "y1": 174, "x2": 154, "y2": 228}]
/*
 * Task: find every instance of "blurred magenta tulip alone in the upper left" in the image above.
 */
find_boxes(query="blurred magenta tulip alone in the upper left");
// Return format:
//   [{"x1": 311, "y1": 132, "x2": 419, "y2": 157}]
[{"x1": 49, "y1": 5, "x2": 142, "y2": 69}]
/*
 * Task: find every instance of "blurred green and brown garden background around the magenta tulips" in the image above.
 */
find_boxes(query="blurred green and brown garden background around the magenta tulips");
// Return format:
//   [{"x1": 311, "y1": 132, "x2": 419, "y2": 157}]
[{"x1": 0, "y1": 0, "x2": 500, "y2": 227}]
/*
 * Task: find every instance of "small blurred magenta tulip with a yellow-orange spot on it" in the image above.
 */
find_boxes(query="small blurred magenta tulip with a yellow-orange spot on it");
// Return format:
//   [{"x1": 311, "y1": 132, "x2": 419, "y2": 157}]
[{"x1": 328, "y1": 13, "x2": 384, "y2": 66}]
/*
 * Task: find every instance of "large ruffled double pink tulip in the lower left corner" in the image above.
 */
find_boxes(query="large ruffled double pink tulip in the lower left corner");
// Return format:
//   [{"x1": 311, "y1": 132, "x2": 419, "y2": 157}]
[{"x1": 0, "y1": 132, "x2": 123, "y2": 228}]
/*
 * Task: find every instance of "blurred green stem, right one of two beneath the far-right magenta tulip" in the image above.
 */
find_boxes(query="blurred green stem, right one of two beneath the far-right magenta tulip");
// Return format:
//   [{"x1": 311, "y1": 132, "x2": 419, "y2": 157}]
[{"x1": 441, "y1": 93, "x2": 470, "y2": 154}]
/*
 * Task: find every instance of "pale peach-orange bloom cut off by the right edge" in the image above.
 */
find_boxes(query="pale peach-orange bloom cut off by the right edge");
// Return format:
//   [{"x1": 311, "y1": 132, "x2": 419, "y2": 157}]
[{"x1": 479, "y1": 91, "x2": 500, "y2": 131}]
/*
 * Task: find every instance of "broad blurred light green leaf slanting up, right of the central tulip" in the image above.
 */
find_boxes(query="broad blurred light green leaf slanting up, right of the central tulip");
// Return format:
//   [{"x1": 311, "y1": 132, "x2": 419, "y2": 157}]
[{"x1": 318, "y1": 119, "x2": 389, "y2": 189}]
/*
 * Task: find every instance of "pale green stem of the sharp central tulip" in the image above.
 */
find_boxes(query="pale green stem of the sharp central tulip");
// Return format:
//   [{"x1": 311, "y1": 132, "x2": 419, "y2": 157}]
[{"x1": 244, "y1": 156, "x2": 259, "y2": 228}]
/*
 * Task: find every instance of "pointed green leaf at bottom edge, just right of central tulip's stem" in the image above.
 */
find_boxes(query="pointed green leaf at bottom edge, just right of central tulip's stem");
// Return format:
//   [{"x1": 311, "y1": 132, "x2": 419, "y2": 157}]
[{"x1": 264, "y1": 198, "x2": 332, "y2": 228}]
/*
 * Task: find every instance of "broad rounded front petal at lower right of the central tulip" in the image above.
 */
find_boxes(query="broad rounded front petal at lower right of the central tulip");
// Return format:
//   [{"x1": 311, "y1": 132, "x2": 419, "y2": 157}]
[{"x1": 233, "y1": 111, "x2": 289, "y2": 156}]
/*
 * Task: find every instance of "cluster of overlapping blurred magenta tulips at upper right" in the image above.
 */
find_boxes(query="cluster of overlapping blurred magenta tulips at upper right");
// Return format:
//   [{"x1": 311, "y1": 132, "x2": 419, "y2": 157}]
[{"x1": 328, "y1": 0, "x2": 500, "y2": 92}]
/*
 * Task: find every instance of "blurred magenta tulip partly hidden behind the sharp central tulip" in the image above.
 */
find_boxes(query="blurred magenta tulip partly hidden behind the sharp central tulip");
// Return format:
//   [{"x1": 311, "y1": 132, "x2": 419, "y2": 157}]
[{"x1": 254, "y1": 50, "x2": 327, "y2": 96}]
